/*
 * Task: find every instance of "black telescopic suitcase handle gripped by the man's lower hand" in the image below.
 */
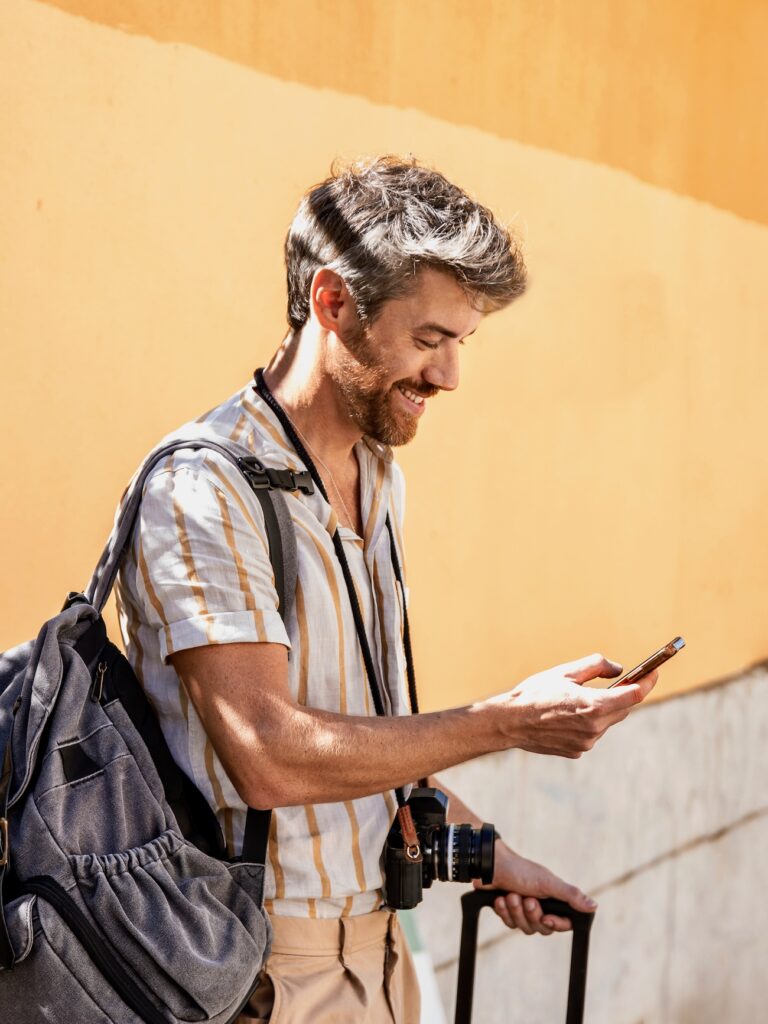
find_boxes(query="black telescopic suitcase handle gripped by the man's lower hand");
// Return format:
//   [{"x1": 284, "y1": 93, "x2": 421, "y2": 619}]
[{"x1": 455, "y1": 889, "x2": 595, "y2": 1024}]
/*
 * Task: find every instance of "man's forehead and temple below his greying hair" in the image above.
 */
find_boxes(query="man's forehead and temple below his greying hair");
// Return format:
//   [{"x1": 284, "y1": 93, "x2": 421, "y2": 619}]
[{"x1": 377, "y1": 267, "x2": 482, "y2": 338}]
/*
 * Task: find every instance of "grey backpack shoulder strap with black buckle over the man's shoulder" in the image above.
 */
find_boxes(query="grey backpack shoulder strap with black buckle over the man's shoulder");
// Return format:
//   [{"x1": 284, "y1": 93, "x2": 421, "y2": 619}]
[{"x1": 85, "y1": 428, "x2": 314, "y2": 620}]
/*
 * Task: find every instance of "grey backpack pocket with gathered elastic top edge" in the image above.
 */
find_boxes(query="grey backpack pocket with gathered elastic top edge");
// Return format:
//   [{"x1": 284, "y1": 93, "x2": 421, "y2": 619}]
[{"x1": 70, "y1": 830, "x2": 268, "y2": 1022}]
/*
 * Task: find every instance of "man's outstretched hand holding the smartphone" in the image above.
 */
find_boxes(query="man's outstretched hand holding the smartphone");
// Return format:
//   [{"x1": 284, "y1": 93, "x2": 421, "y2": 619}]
[{"x1": 487, "y1": 654, "x2": 658, "y2": 758}]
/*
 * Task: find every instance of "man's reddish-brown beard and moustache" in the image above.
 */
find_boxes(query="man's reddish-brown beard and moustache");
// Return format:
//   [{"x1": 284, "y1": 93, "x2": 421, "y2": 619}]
[{"x1": 334, "y1": 326, "x2": 439, "y2": 447}]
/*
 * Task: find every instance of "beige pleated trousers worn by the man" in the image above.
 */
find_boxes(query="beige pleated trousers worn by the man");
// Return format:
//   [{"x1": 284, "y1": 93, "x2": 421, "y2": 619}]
[{"x1": 237, "y1": 910, "x2": 420, "y2": 1024}]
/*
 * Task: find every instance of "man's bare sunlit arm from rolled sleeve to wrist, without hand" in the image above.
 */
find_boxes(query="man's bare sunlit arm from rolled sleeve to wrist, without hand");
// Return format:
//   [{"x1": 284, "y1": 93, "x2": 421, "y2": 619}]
[{"x1": 172, "y1": 644, "x2": 512, "y2": 808}]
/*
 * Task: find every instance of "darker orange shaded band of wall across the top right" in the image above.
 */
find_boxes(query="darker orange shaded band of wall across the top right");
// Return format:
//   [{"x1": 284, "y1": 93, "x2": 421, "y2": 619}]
[{"x1": 41, "y1": 0, "x2": 768, "y2": 223}]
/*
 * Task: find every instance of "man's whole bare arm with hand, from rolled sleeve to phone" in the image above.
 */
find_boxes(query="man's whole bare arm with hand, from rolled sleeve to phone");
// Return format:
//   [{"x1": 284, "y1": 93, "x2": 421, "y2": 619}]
[{"x1": 171, "y1": 643, "x2": 655, "y2": 820}]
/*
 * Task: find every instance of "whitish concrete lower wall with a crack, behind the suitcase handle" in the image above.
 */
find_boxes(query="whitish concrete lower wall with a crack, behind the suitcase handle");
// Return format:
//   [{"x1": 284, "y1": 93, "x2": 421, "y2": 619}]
[{"x1": 418, "y1": 669, "x2": 768, "y2": 1024}]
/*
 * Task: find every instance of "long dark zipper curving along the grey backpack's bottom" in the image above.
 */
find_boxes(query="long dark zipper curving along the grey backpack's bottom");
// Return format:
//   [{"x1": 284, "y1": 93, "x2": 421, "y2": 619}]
[{"x1": 24, "y1": 876, "x2": 168, "y2": 1024}]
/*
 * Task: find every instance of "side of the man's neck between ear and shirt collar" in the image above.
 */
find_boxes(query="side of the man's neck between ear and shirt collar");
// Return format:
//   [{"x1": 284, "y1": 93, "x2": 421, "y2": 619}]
[{"x1": 264, "y1": 323, "x2": 362, "y2": 467}]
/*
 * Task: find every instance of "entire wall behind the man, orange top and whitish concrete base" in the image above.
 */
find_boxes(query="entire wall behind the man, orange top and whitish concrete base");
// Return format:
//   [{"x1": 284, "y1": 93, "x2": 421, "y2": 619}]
[{"x1": 0, "y1": 0, "x2": 768, "y2": 1024}]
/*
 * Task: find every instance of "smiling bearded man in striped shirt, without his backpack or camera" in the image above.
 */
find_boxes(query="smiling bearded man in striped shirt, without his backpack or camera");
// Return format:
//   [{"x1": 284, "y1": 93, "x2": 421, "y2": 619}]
[{"x1": 120, "y1": 158, "x2": 655, "y2": 1024}]
